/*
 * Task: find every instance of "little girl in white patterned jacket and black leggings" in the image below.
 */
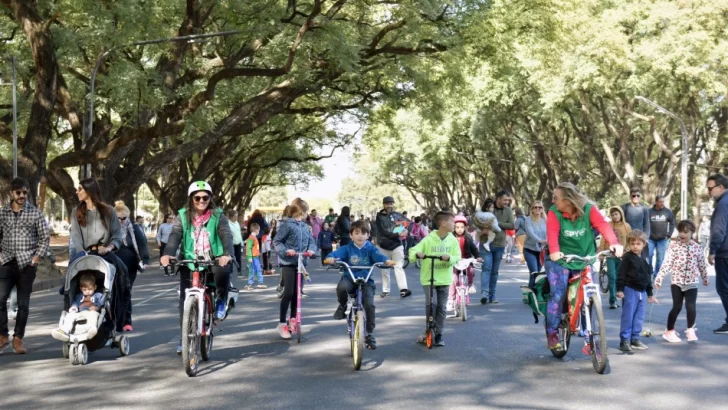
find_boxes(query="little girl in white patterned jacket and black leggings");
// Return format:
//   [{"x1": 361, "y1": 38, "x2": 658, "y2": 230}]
[{"x1": 655, "y1": 220, "x2": 709, "y2": 343}]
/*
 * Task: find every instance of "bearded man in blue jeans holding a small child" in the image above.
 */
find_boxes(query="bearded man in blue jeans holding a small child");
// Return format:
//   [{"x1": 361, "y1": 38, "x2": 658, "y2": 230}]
[{"x1": 480, "y1": 190, "x2": 516, "y2": 304}]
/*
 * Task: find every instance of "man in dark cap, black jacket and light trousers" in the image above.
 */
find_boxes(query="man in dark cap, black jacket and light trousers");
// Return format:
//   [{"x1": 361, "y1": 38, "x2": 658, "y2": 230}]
[{"x1": 376, "y1": 196, "x2": 412, "y2": 298}]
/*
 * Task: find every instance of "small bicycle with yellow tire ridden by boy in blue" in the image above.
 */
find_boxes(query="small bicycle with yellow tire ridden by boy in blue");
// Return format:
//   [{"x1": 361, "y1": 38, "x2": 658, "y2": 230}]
[{"x1": 334, "y1": 261, "x2": 387, "y2": 370}]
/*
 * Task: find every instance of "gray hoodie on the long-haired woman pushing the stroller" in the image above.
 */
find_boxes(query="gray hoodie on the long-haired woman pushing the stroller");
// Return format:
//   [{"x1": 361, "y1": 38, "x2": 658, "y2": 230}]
[{"x1": 69, "y1": 208, "x2": 121, "y2": 256}]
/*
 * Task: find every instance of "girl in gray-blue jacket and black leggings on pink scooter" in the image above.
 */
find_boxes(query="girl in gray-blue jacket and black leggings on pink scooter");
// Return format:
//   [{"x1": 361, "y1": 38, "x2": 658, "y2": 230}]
[{"x1": 273, "y1": 198, "x2": 316, "y2": 339}]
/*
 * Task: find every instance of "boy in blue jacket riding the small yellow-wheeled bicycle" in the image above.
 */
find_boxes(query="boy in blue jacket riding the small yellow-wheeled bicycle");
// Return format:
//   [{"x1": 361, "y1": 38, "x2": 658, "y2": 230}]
[{"x1": 326, "y1": 220, "x2": 394, "y2": 350}]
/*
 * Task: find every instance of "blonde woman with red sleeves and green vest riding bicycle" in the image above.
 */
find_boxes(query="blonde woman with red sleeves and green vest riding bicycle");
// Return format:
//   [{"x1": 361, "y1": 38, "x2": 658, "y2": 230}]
[{"x1": 546, "y1": 182, "x2": 622, "y2": 350}]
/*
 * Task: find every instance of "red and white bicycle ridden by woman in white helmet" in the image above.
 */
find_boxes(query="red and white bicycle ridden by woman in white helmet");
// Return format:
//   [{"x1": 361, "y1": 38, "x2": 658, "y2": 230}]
[{"x1": 170, "y1": 259, "x2": 235, "y2": 377}]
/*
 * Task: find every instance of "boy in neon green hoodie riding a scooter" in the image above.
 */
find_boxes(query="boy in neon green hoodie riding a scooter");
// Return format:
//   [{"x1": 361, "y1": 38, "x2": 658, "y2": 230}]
[{"x1": 409, "y1": 211, "x2": 461, "y2": 346}]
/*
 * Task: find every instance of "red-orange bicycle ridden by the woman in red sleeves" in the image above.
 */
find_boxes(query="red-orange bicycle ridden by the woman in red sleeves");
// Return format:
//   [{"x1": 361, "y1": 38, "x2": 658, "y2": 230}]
[{"x1": 551, "y1": 251, "x2": 611, "y2": 374}]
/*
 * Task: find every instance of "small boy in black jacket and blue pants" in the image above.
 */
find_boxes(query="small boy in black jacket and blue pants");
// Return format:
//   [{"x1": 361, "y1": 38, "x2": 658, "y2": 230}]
[{"x1": 617, "y1": 229, "x2": 657, "y2": 352}]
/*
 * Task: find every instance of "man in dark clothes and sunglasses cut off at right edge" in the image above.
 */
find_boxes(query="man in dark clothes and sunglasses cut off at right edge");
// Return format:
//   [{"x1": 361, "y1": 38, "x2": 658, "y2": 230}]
[{"x1": 705, "y1": 174, "x2": 728, "y2": 334}]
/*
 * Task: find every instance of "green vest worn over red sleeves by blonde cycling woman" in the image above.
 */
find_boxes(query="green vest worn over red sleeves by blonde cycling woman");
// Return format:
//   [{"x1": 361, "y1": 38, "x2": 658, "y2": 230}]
[{"x1": 551, "y1": 204, "x2": 597, "y2": 270}]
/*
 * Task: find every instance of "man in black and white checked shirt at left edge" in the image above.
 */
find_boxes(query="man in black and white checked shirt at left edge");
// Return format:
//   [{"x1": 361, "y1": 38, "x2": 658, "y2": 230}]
[{"x1": 0, "y1": 178, "x2": 50, "y2": 354}]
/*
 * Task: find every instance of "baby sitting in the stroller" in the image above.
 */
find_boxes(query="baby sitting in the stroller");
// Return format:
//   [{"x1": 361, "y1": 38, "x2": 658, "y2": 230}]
[{"x1": 51, "y1": 273, "x2": 104, "y2": 342}]
